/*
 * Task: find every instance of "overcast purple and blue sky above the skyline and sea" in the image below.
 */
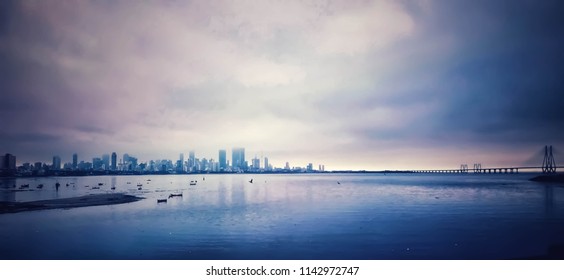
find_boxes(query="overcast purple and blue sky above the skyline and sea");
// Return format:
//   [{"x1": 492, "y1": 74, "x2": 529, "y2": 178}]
[{"x1": 0, "y1": 0, "x2": 564, "y2": 170}]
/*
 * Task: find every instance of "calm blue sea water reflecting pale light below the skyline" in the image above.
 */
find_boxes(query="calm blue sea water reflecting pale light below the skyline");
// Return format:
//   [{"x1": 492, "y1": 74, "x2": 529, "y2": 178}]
[{"x1": 0, "y1": 174, "x2": 564, "y2": 259}]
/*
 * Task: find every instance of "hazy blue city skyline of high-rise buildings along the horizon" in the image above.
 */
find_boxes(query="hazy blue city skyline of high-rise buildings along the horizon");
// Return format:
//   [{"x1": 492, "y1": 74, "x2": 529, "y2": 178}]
[{"x1": 0, "y1": 148, "x2": 325, "y2": 176}]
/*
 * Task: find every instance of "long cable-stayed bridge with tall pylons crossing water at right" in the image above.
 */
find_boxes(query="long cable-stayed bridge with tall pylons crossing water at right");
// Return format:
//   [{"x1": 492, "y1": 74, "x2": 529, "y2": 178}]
[{"x1": 407, "y1": 146, "x2": 564, "y2": 174}]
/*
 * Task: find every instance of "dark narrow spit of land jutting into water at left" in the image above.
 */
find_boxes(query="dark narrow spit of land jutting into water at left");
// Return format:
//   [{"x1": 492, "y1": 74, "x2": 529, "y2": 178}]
[{"x1": 0, "y1": 193, "x2": 144, "y2": 215}]
